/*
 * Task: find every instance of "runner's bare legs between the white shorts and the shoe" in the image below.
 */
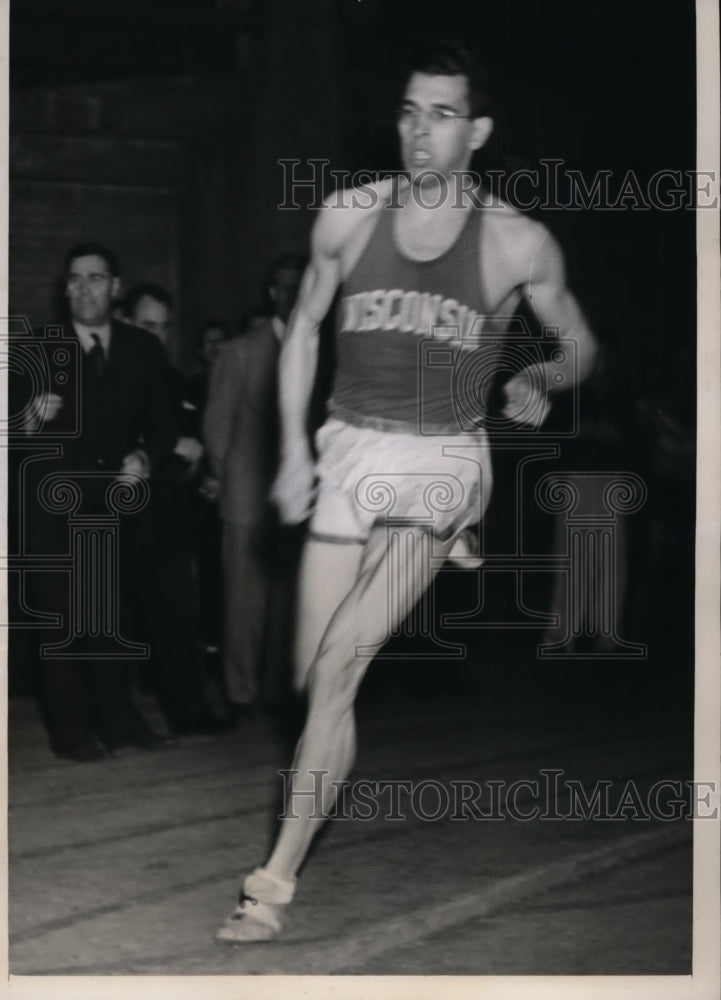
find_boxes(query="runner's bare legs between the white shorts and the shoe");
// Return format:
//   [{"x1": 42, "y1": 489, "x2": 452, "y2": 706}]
[{"x1": 265, "y1": 527, "x2": 452, "y2": 879}]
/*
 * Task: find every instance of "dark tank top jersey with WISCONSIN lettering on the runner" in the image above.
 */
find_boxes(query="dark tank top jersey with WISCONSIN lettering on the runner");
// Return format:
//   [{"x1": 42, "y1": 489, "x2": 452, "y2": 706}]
[{"x1": 331, "y1": 193, "x2": 497, "y2": 433}]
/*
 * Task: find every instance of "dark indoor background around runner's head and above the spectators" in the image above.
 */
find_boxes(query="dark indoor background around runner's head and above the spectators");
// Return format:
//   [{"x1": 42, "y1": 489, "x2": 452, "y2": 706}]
[{"x1": 10, "y1": 0, "x2": 695, "y2": 378}]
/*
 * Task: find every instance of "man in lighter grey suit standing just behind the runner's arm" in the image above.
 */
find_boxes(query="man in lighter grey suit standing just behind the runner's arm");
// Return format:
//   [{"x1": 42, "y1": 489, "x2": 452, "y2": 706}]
[{"x1": 203, "y1": 256, "x2": 303, "y2": 719}]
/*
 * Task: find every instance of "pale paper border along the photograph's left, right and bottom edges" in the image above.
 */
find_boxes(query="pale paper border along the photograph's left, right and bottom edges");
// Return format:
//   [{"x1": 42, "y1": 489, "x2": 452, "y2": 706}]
[{"x1": 0, "y1": 0, "x2": 721, "y2": 1000}]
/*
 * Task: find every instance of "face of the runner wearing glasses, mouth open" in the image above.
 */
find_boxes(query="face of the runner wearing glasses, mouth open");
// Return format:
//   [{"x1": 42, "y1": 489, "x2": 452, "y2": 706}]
[{"x1": 398, "y1": 73, "x2": 489, "y2": 185}]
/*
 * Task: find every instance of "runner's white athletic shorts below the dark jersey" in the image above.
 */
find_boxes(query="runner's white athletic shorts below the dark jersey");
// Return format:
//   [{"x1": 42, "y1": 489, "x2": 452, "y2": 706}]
[{"x1": 310, "y1": 417, "x2": 492, "y2": 543}]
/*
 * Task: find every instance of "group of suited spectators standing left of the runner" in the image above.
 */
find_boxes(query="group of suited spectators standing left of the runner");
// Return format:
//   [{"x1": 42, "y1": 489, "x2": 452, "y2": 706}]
[{"x1": 10, "y1": 242, "x2": 303, "y2": 762}]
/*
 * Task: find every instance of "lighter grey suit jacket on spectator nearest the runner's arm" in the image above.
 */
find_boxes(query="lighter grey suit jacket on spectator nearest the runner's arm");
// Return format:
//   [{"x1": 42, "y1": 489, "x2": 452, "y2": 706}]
[{"x1": 203, "y1": 322, "x2": 280, "y2": 526}]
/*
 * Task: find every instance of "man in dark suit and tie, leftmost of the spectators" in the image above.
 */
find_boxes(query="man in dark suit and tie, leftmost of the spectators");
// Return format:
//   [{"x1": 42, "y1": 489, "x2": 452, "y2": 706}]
[{"x1": 21, "y1": 243, "x2": 176, "y2": 761}]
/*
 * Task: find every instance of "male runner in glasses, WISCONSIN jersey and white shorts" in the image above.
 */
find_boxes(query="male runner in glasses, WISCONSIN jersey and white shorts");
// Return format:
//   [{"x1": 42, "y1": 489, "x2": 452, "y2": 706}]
[{"x1": 217, "y1": 43, "x2": 595, "y2": 943}]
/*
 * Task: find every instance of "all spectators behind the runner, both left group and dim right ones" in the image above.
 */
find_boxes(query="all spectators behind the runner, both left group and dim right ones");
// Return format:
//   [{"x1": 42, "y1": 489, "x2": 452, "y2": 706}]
[{"x1": 8, "y1": 243, "x2": 694, "y2": 762}]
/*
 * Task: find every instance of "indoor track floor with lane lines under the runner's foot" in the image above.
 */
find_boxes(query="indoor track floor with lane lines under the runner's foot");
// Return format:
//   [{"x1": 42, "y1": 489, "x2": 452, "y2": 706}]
[{"x1": 9, "y1": 632, "x2": 692, "y2": 976}]
